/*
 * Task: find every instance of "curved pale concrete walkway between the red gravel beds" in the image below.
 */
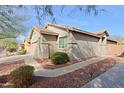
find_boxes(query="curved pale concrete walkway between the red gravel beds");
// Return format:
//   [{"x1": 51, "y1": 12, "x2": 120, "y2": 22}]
[{"x1": 35, "y1": 57, "x2": 105, "y2": 77}]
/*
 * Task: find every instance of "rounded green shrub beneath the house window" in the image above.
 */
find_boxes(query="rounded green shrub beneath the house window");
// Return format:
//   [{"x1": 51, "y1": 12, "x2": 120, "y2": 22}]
[{"x1": 50, "y1": 52, "x2": 69, "y2": 65}]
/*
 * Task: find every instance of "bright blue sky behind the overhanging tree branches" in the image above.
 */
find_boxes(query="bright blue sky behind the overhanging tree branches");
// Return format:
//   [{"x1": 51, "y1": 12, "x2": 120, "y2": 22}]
[{"x1": 18, "y1": 5, "x2": 124, "y2": 41}]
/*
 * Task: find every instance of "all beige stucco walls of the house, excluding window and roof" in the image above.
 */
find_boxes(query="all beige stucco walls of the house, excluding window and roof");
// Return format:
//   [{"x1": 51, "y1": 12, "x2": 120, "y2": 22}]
[{"x1": 31, "y1": 26, "x2": 118, "y2": 61}]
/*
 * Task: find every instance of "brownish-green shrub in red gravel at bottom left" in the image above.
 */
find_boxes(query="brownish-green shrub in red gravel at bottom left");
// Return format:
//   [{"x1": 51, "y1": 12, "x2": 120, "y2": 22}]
[{"x1": 8, "y1": 65, "x2": 34, "y2": 87}]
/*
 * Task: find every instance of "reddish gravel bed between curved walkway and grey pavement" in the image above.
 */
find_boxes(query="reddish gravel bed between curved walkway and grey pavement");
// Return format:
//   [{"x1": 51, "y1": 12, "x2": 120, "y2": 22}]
[{"x1": 0, "y1": 58, "x2": 117, "y2": 88}]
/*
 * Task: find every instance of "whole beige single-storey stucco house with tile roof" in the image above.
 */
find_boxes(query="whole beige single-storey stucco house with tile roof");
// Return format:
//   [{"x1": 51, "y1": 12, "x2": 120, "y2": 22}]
[{"x1": 29, "y1": 23, "x2": 117, "y2": 61}]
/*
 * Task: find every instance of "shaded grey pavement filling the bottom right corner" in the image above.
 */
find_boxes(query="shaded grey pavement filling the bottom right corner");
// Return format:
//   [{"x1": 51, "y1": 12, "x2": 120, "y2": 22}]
[{"x1": 82, "y1": 59, "x2": 124, "y2": 88}]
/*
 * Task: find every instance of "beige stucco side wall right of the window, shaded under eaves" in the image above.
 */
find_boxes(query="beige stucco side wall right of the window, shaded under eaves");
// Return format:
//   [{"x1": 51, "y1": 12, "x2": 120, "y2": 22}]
[{"x1": 68, "y1": 32, "x2": 99, "y2": 61}]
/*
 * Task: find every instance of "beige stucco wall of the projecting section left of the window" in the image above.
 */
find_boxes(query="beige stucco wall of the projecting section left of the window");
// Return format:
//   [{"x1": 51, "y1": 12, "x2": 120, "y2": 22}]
[{"x1": 30, "y1": 28, "x2": 57, "y2": 59}]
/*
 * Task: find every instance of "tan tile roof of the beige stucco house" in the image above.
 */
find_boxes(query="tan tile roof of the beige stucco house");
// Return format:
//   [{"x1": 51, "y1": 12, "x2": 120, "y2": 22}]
[{"x1": 29, "y1": 23, "x2": 117, "y2": 42}]
